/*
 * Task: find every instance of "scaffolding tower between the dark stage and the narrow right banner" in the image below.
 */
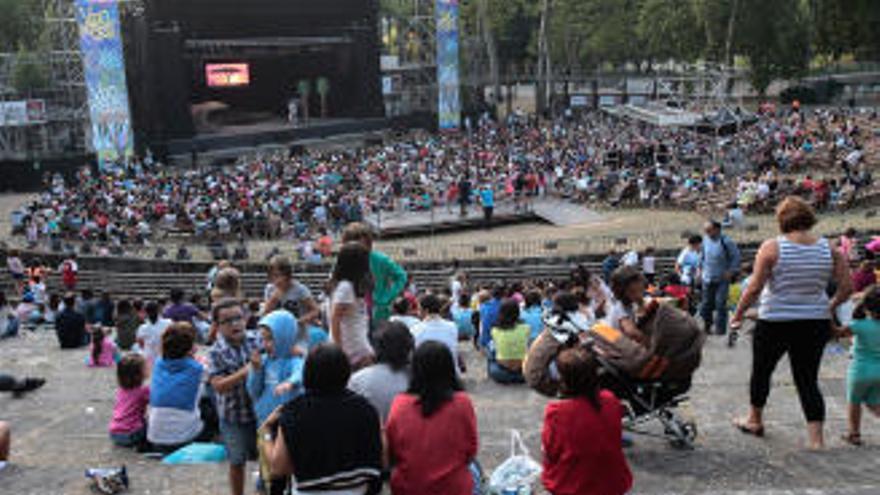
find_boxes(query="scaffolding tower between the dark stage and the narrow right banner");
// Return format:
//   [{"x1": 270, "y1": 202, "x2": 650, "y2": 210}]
[{"x1": 379, "y1": 0, "x2": 438, "y2": 117}]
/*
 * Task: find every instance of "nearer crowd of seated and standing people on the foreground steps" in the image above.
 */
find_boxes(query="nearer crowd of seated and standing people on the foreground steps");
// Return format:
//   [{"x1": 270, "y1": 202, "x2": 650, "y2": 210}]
[{"x1": 0, "y1": 197, "x2": 880, "y2": 495}]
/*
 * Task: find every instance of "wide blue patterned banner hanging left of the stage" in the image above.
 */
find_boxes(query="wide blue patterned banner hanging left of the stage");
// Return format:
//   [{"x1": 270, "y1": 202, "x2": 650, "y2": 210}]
[{"x1": 76, "y1": 0, "x2": 134, "y2": 168}]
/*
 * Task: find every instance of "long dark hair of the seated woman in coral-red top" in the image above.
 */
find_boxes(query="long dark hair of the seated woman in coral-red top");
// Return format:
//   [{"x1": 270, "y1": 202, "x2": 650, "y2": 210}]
[{"x1": 407, "y1": 341, "x2": 463, "y2": 418}]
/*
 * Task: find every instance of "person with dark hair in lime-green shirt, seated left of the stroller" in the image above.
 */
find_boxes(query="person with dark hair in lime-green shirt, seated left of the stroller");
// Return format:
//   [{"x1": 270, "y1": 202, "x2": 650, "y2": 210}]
[{"x1": 488, "y1": 299, "x2": 531, "y2": 384}]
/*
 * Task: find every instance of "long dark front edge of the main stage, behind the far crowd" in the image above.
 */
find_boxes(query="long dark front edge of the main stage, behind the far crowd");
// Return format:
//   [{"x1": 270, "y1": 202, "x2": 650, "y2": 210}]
[{"x1": 167, "y1": 118, "x2": 391, "y2": 161}]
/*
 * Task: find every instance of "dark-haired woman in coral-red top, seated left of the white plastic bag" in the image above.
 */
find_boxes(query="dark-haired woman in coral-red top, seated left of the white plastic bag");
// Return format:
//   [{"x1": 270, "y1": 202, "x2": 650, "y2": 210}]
[{"x1": 386, "y1": 342, "x2": 478, "y2": 495}]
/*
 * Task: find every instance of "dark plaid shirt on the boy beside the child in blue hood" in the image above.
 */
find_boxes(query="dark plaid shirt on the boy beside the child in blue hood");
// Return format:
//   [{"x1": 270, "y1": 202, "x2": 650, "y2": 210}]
[{"x1": 208, "y1": 334, "x2": 260, "y2": 424}]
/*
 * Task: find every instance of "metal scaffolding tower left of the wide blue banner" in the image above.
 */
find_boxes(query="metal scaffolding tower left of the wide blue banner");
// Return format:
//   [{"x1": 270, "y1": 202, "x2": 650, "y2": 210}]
[{"x1": 0, "y1": 0, "x2": 89, "y2": 161}]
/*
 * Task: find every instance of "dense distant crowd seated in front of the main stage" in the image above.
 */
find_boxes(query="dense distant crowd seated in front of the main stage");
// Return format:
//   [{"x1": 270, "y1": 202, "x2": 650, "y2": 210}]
[{"x1": 12, "y1": 108, "x2": 878, "y2": 259}]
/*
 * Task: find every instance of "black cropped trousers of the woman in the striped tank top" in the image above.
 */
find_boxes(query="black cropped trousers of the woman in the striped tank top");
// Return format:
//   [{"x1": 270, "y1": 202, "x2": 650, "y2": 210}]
[{"x1": 750, "y1": 320, "x2": 831, "y2": 422}]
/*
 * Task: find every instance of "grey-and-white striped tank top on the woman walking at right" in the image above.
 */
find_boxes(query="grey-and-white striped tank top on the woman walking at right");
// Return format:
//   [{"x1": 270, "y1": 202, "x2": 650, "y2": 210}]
[{"x1": 758, "y1": 236, "x2": 834, "y2": 321}]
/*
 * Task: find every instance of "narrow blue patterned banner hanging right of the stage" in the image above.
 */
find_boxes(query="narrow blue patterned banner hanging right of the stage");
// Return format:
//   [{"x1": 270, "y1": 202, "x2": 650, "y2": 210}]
[{"x1": 434, "y1": 0, "x2": 461, "y2": 130}]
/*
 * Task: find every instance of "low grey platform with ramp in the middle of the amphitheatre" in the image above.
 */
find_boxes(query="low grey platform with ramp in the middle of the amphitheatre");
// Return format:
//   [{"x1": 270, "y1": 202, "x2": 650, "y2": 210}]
[{"x1": 367, "y1": 198, "x2": 604, "y2": 240}]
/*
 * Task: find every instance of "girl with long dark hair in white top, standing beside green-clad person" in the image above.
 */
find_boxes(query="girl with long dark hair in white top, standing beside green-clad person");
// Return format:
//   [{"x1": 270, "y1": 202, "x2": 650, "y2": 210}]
[{"x1": 330, "y1": 242, "x2": 373, "y2": 370}]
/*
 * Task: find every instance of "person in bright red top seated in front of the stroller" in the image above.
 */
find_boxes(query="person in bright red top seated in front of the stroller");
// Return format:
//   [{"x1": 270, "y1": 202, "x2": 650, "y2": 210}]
[{"x1": 541, "y1": 348, "x2": 633, "y2": 495}]
